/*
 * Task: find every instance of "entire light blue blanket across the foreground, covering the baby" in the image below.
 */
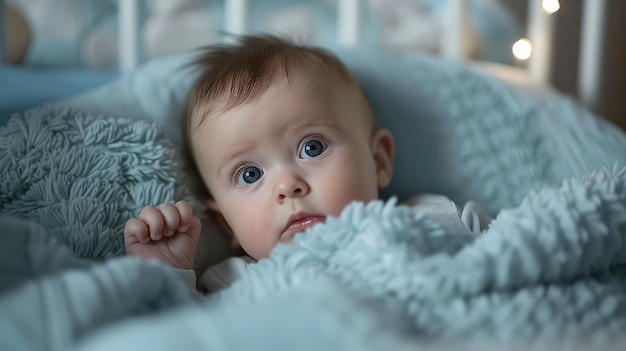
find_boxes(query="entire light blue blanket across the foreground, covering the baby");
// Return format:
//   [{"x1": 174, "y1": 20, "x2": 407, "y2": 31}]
[{"x1": 0, "y1": 168, "x2": 626, "y2": 350}]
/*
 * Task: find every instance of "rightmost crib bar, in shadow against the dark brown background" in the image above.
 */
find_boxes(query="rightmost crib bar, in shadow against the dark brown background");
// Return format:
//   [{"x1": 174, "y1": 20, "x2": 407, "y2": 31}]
[{"x1": 577, "y1": 0, "x2": 607, "y2": 111}]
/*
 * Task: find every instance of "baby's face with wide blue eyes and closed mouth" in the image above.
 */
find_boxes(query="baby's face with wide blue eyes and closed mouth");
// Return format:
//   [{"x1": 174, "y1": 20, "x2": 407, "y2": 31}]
[{"x1": 191, "y1": 75, "x2": 392, "y2": 259}]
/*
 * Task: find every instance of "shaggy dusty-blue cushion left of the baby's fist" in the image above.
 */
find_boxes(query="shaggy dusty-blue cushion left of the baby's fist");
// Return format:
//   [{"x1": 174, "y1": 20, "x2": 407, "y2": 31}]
[{"x1": 0, "y1": 105, "x2": 182, "y2": 258}]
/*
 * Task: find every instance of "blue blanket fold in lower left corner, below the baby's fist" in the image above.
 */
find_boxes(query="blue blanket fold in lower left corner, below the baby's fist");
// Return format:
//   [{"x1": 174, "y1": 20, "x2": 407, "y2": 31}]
[{"x1": 0, "y1": 216, "x2": 193, "y2": 350}]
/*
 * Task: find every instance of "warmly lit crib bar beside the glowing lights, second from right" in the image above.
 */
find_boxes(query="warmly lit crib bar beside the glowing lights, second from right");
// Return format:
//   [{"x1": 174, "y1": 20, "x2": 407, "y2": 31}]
[{"x1": 528, "y1": 0, "x2": 554, "y2": 84}]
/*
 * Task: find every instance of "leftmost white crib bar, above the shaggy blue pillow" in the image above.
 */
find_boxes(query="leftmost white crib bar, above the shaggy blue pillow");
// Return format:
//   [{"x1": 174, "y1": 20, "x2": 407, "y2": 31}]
[{"x1": 118, "y1": 0, "x2": 141, "y2": 72}]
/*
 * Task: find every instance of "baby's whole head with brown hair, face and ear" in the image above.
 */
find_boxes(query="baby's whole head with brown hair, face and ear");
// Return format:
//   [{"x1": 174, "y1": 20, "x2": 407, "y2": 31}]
[{"x1": 183, "y1": 36, "x2": 394, "y2": 259}]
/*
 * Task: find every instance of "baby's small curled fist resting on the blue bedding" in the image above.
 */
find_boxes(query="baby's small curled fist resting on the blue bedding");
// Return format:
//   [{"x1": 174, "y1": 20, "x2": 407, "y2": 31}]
[{"x1": 124, "y1": 201, "x2": 201, "y2": 269}]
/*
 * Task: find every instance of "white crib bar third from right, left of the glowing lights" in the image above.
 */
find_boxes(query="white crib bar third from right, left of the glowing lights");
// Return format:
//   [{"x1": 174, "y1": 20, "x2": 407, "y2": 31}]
[{"x1": 440, "y1": 0, "x2": 470, "y2": 59}]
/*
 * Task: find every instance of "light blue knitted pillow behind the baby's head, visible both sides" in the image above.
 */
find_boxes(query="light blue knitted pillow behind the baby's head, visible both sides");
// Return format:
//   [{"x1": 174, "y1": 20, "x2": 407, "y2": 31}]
[{"x1": 63, "y1": 49, "x2": 626, "y2": 215}]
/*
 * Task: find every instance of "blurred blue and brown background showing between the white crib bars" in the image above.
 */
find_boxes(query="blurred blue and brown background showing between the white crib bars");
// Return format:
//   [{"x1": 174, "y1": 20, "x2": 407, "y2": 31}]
[{"x1": 4, "y1": 0, "x2": 626, "y2": 130}]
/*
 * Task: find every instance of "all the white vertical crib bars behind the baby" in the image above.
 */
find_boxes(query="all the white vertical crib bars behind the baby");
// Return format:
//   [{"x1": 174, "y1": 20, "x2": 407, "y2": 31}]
[{"x1": 112, "y1": 0, "x2": 580, "y2": 86}]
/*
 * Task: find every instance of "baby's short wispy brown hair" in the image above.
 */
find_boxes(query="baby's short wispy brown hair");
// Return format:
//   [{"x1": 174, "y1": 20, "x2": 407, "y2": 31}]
[{"x1": 182, "y1": 35, "x2": 373, "y2": 204}]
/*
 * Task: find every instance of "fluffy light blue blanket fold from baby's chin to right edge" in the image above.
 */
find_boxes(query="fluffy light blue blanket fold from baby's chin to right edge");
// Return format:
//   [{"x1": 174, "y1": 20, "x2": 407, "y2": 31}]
[{"x1": 211, "y1": 167, "x2": 626, "y2": 341}]
